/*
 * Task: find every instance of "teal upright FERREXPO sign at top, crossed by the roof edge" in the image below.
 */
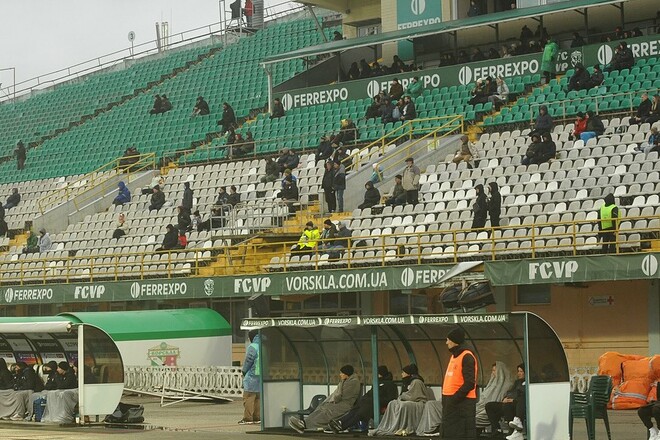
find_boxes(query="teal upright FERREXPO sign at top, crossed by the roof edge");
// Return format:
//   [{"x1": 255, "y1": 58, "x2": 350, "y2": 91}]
[{"x1": 396, "y1": 0, "x2": 442, "y2": 60}]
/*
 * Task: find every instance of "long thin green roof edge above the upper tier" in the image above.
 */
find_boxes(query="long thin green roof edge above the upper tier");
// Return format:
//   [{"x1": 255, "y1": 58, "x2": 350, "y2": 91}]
[{"x1": 263, "y1": 0, "x2": 623, "y2": 65}]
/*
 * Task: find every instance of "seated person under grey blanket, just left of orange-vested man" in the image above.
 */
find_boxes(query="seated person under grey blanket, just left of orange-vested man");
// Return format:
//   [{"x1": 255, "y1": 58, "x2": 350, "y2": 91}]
[{"x1": 370, "y1": 364, "x2": 434, "y2": 436}]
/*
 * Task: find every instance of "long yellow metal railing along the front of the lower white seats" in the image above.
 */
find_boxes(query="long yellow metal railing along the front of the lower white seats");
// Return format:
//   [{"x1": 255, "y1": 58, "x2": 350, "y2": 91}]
[{"x1": 0, "y1": 215, "x2": 660, "y2": 285}]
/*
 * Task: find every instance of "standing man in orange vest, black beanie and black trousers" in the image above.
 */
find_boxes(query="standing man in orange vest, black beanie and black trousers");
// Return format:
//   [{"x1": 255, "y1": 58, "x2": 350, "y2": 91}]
[{"x1": 441, "y1": 327, "x2": 478, "y2": 439}]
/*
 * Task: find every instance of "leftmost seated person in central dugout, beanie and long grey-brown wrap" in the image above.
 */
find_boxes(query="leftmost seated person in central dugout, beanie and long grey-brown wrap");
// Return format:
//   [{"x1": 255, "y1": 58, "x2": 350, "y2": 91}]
[{"x1": 289, "y1": 365, "x2": 362, "y2": 434}]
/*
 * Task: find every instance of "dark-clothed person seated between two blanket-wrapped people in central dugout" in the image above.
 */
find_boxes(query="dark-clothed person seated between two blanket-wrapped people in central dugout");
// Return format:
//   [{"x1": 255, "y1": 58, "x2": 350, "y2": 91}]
[{"x1": 328, "y1": 365, "x2": 399, "y2": 434}]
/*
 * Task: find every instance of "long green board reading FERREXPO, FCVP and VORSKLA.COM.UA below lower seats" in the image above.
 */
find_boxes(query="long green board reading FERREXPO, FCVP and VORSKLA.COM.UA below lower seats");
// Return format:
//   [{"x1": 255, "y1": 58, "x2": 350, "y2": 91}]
[{"x1": 0, "y1": 263, "x2": 465, "y2": 305}]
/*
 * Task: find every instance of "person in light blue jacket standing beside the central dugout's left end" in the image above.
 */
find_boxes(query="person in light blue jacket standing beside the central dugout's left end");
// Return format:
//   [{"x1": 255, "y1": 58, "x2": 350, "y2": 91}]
[{"x1": 238, "y1": 330, "x2": 261, "y2": 425}]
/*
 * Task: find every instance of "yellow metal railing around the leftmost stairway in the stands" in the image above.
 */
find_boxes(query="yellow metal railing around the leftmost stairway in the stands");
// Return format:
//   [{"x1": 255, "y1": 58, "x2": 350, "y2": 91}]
[{"x1": 37, "y1": 153, "x2": 156, "y2": 214}]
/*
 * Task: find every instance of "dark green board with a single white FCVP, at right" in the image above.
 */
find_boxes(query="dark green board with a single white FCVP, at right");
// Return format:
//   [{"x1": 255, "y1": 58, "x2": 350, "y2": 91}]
[{"x1": 484, "y1": 253, "x2": 660, "y2": 286}]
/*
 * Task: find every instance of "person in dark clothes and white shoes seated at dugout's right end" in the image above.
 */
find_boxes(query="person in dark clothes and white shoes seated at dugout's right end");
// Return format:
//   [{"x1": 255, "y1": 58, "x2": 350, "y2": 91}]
[{"x1": 486, "y1": 364, "x2": 527, "y2": 440}]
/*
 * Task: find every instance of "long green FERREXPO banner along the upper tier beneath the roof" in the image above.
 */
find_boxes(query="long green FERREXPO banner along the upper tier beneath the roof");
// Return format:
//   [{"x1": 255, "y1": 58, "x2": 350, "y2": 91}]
[{"x1": 275, "y1": 33, "x2": 660, "y2": 110}]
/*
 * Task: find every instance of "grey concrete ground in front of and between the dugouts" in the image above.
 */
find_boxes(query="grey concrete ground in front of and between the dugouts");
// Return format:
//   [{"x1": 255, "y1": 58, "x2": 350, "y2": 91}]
[{"x1": 0, "y1": 396, "x2": 646, "y2": 440}]
